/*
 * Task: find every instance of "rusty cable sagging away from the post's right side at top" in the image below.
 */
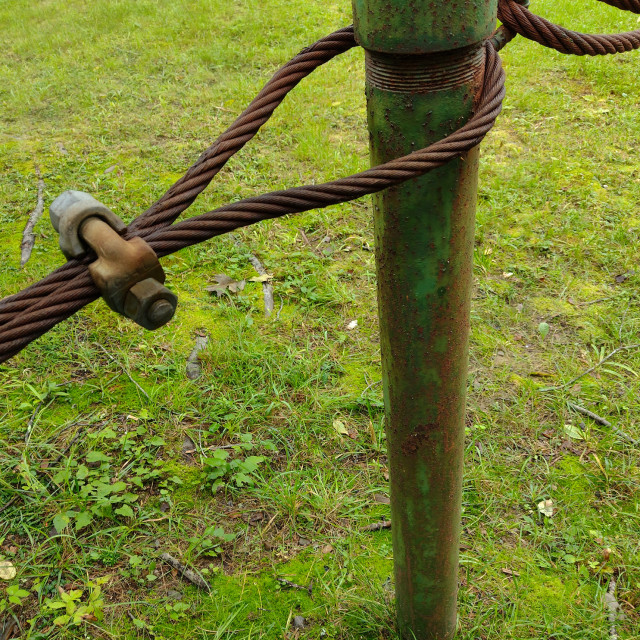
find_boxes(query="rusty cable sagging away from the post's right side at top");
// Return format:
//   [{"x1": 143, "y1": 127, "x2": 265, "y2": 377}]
[{"x1": 498, "y1": 0, "x2": 640, "y2": 56}]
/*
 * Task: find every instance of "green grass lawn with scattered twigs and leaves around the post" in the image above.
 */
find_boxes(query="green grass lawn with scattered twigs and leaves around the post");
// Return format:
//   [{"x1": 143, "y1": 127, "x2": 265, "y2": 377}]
[{"x1": 0, "y1": 0, "x2": 640, "y2": 640}]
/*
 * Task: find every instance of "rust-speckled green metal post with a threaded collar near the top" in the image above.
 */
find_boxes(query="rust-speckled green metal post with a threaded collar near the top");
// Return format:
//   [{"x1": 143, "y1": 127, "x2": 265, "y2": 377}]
[{"x1": 353, "y1": 0, "x2": 497, "y2": 640}]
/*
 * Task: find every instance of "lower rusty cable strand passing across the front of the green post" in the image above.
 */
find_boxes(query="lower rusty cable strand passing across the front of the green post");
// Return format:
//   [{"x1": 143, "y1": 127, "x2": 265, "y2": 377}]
[{"x1": 0, "y1": 41, "x2": 505, "y2": 362}]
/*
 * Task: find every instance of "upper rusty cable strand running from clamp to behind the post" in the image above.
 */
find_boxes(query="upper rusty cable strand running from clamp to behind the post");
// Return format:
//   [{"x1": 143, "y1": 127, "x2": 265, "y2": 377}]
[{"x1": 0, "y1": 27, "x2": 356, "y2": 326}]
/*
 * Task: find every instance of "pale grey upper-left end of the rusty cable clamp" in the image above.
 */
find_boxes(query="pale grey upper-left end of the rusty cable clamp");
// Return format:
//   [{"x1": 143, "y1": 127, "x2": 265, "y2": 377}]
[{"x1": 49, "y1": 191, "x2": 126, "y2": 260}]
